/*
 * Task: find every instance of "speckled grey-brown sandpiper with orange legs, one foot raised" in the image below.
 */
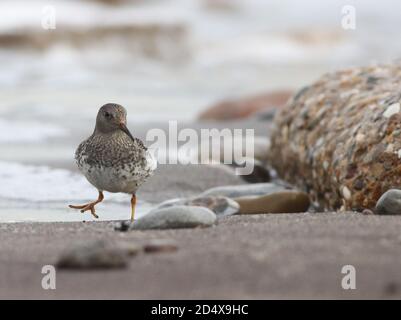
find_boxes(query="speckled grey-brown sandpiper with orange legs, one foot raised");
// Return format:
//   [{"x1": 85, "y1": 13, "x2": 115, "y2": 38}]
[{"x1": 69, "y1": 103, "x2": 157, "y2": 221}]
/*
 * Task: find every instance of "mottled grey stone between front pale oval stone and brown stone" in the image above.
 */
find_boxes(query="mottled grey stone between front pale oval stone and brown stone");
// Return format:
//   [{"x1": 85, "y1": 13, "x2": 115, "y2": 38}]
[{"x1": 157, "y1": 196, "x2": 239, "y2": 217}]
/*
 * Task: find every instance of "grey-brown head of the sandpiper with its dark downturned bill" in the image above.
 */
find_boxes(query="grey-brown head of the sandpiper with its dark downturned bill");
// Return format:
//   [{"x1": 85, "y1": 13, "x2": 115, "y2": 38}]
[{"x1": 95, "y1": 103, "x2": 134, "y2": 140}]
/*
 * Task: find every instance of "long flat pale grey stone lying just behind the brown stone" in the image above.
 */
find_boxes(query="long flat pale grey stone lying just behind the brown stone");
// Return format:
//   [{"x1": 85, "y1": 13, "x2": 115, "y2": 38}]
[{"x1": 200, "y1": 183, "x2": 288, "y2": 198}]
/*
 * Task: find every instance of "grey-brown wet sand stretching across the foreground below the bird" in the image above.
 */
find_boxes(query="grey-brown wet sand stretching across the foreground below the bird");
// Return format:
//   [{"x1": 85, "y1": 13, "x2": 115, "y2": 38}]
[{"x1": 0, "y1": 213, "x2": 401, "y2": 299}]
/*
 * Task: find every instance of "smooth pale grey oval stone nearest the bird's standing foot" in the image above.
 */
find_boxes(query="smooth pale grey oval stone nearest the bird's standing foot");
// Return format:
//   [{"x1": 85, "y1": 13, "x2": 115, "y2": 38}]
[{"x1": 131, "y1": 206, "x2": 216, "y2": 230}]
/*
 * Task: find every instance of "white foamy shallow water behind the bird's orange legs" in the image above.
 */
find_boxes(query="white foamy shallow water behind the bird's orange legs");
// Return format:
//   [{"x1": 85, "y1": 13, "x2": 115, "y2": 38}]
[{"x1": 0, "y1": 161, "x2": 153, "y2": 222}]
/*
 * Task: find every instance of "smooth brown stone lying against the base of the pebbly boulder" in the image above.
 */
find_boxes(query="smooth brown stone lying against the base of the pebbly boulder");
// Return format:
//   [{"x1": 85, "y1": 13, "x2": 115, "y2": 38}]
[{"x1": 234, "y1": 191, "x2": 310, "y2": 214}]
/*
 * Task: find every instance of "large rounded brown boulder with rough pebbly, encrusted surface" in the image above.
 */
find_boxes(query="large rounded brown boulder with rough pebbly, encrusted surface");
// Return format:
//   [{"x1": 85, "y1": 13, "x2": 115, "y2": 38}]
[{"x1": 270, "y1": 64, "x2": 401, "y2": 211}]
